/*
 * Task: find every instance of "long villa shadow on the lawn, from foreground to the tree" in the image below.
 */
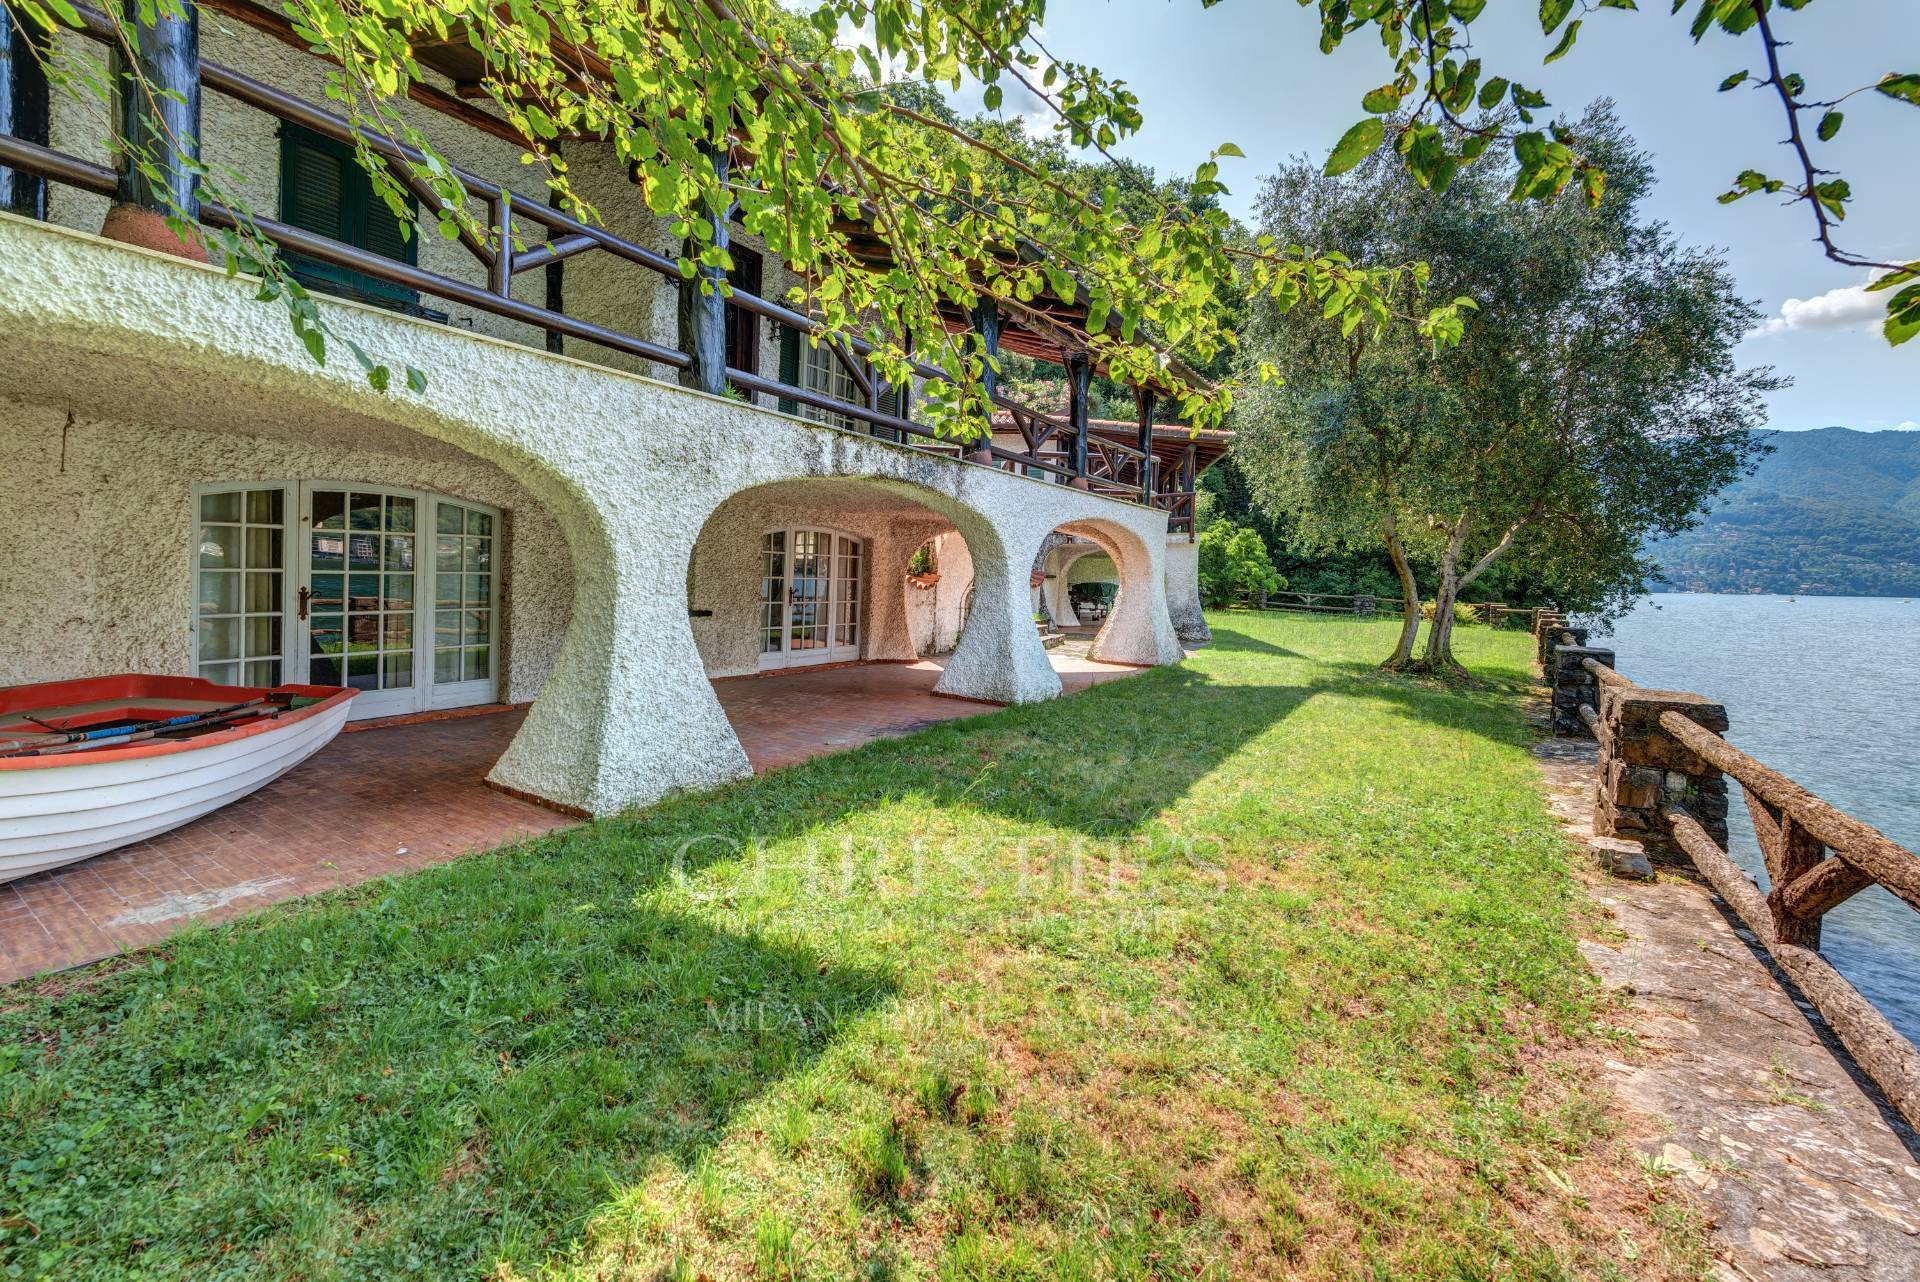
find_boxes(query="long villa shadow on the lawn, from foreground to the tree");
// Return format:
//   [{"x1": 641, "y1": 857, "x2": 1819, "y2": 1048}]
[{"x1": 0, "y1": 614, "x2": 1536, "y2": 1278}]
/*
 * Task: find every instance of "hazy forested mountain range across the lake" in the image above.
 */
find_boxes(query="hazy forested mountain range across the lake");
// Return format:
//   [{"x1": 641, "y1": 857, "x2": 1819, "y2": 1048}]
[{"x1": 1651, "y1": 428, "x2": 1920, "y2": 597}]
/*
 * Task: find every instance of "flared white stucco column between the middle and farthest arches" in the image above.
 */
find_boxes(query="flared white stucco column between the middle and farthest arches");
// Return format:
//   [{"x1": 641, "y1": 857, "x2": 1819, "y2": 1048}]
[{"x1": 933, "y1": 526, "x2": 1060, "y2": 702}]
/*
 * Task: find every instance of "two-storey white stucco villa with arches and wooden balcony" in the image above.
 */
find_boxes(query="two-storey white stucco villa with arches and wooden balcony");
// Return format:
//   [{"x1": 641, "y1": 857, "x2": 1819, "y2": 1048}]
[{"x1": 0, "y1": 0, "x2": 1225, "y2": 814}]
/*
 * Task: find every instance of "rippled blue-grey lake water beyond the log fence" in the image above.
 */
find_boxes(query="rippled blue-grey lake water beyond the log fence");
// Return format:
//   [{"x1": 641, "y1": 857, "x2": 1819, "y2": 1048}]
[{"x1": 1594, "y1": 593, "x2": 1920, "y2": 1042}]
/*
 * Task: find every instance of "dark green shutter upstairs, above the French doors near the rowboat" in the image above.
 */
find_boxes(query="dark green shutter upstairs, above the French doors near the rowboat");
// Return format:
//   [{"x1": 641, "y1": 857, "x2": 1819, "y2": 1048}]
[{"x1": 280, "y1": 123, "x2": 419, "y2": 311}]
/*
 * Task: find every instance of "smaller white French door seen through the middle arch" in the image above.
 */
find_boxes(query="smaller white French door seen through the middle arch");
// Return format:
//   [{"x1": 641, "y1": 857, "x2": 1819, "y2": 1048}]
[{"x1": 760, "y1": 530, "x2": 860, "y2": 672}]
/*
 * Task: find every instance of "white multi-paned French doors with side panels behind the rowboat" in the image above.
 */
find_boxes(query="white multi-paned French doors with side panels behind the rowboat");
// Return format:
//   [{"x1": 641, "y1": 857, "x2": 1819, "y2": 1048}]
[{"x1": 194, "y1": 482, "x2": 499, "y2": 720}]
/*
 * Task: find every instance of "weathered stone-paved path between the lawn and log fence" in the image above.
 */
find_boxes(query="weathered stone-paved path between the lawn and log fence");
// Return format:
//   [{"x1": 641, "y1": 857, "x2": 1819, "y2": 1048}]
[{"x1": 1536, "y1": 725, "x2": 1920, "y2": 1282}]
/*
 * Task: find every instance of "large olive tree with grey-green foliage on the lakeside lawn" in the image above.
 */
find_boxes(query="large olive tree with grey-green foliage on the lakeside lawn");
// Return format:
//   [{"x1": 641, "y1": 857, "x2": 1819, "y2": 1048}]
[{"x1": 1238, "y1": 104, "x2": 1780, "y2": 672}]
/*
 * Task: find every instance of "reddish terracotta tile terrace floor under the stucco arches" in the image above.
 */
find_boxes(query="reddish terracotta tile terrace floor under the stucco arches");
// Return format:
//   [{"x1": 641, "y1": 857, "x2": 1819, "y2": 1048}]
[{"x1": 0, "y1": 639, "x2": 1140, "y2": 983}]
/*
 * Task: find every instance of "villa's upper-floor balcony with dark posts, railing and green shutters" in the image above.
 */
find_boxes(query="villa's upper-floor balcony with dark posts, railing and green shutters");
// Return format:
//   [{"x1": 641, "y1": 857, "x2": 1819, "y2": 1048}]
[{"x1": 0, "y1": 0, "x2": 1225, "y2": 534}]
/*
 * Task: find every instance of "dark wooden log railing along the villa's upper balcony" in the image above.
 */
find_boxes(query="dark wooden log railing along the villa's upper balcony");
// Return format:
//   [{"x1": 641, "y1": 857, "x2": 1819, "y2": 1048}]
[{"x1": 0, "y1": 8, "x2": 1194, "y2": 534}]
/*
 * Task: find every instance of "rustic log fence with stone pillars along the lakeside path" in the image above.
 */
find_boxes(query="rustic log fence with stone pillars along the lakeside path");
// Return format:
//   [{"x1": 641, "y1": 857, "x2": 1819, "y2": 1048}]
[{"x1": 1546, "y1": 628, "x2": 1920, "y2": 1127}]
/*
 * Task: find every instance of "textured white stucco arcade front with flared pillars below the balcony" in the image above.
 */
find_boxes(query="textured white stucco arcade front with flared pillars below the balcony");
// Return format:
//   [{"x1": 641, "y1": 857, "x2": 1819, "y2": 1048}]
[{"x1": 0, "y1": 215, "x2": 1179, "y2": 814}]
